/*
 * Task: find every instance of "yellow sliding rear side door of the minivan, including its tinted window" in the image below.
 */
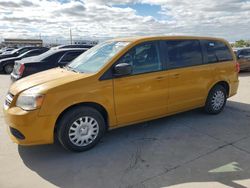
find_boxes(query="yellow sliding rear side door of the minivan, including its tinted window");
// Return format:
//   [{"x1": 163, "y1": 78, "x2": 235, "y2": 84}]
[{"x1": 166, "y1": 40, "x2": 212, "y2": 113}]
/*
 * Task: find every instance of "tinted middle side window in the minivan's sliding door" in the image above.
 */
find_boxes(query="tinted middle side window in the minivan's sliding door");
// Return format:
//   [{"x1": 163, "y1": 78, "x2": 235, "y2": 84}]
[{"x1": 166, "y1": 40, "x2": 202, "y2": 68}]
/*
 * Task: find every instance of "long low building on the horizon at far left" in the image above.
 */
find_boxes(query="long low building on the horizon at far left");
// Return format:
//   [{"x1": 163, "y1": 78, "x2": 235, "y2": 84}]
[{"x1": 2, "y1": 39, "x2": 43, "y2": 48}]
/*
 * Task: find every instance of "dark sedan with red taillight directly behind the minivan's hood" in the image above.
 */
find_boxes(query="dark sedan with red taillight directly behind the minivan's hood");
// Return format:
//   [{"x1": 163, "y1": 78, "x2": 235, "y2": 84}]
[{"x1": 11, "y1": 48, "x2": 87, "y2": 81}]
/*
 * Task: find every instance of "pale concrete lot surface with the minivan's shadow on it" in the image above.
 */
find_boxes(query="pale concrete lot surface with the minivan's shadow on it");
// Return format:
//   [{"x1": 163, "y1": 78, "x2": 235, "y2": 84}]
[{"x1": 0, "y1": 73, "x2": 250, "y2": 188}]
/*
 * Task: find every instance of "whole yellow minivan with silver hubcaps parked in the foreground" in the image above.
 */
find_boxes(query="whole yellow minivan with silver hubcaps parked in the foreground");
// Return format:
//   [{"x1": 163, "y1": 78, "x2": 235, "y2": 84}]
[{"x1": 4, "y1": 36, "x2": 239, "y2": 151}]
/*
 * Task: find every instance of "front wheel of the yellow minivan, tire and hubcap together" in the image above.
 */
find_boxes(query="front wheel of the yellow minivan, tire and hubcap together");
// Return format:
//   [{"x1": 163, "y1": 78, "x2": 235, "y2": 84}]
[{"x1": 57, "y1": 107, "x2": 105, "y2": 152}]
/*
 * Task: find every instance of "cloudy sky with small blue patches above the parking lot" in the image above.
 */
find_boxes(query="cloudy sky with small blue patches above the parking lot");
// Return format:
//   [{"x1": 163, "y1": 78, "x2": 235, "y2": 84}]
[{"x1": 0, "y1": 0, "x2": 250, "y2": 43}]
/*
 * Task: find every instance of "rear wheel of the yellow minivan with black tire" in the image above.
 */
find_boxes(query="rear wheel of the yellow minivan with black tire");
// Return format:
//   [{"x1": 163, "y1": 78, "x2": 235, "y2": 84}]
[{"x1": 205, "y1": 85, "x2": 227, "y2": 114}]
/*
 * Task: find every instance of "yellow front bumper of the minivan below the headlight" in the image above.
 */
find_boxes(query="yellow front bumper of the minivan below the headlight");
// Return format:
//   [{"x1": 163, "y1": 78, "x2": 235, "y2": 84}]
[{"x1": 4, "y1": 107, "x2": 56, "y2": 145}]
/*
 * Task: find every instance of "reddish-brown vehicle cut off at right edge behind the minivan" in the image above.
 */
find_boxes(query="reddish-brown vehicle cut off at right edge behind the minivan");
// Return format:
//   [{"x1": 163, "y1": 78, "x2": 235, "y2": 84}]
[{"x1": 236, "y1": 48, "x2": 250, "y2": 71}]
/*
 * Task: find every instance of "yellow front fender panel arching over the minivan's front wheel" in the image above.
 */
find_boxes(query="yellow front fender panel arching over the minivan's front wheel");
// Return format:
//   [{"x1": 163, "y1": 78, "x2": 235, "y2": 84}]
[{"x1": 39, "y1": 81, "x2": 116, "y2": 126}]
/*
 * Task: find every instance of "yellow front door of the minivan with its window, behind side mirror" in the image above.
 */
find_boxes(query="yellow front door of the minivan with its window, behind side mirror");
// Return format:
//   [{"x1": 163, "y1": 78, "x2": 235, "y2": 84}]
[{"x1": 113, "y1": 42, "x2": 168, "y2": 125}]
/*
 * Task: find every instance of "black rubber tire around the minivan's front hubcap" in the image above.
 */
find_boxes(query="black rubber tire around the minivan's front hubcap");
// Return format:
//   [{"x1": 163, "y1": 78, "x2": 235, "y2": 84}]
[{"x1": 57, "y1": 106, "x2": 106, "y2": 152}]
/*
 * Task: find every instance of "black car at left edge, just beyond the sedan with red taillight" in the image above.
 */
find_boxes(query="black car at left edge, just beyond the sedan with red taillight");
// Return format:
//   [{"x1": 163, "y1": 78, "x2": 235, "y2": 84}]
[{"x1": 0, "y1": 48, "x2": 48, "y2": 74}]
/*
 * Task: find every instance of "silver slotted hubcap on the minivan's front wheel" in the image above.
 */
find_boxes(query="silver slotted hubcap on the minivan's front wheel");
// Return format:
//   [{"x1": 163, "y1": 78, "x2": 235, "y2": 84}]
[{"x1": 69, "y1": 116, "x2": 99, "y2": 146}]
